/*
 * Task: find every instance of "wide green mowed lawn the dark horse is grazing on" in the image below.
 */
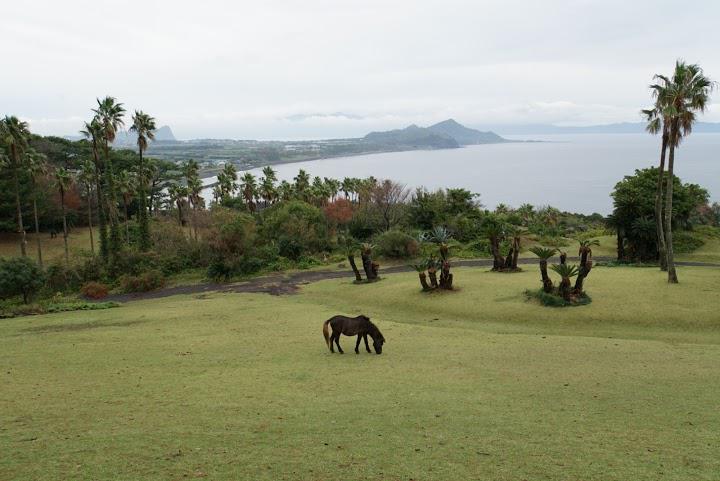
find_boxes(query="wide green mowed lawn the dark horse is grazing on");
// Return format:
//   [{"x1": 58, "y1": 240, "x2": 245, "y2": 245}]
[{"x1": 0, "y1": 267, "x2": 720, "y2": 481}]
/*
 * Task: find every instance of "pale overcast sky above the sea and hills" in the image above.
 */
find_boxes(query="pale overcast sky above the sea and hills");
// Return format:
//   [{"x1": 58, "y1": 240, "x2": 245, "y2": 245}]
[{"x1": 0, "y1": 0, "x2": 720, "y2": 139}]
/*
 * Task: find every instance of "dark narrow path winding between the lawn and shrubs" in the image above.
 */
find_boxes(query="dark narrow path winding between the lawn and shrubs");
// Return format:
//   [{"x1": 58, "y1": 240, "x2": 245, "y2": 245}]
[{"x1": 103, "y1": 257, "x2": 720, "y2": 302}]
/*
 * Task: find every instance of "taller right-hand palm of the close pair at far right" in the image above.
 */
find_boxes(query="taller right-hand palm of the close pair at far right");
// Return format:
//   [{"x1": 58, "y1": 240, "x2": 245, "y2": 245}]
[{"x1": 657, "y1": 60, "x2": 713, "y2": 284}]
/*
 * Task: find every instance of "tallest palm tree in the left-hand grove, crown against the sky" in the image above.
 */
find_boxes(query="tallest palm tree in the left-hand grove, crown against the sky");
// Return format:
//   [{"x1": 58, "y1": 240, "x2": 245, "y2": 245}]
[{"x1": 93, "y1": 96, "x2": 125, "y2": 257}]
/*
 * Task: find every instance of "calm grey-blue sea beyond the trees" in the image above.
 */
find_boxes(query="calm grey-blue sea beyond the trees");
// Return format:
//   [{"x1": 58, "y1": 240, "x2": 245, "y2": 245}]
[{"x1": 198, "y1": 134, "x2": 720, "y2": 214}]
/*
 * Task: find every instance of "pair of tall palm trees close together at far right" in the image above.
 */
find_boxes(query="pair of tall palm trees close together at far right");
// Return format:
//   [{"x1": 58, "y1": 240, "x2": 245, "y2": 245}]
[{"x1": 642, "y1": 60, "x2": 715, "y2": 284}]
